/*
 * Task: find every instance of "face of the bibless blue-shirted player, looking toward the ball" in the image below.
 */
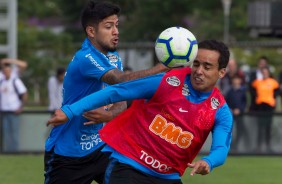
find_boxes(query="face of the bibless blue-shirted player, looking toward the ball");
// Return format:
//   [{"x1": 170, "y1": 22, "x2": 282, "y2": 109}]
[{"x1": 92, "y1": 15, "x2": 119, "y2": 54}]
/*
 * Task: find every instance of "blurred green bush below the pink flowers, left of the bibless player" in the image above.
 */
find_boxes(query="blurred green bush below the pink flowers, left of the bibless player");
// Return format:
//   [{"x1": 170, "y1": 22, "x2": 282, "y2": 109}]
[{"x1": 18, "y1": 24, "x2": 77, "y2": 105}]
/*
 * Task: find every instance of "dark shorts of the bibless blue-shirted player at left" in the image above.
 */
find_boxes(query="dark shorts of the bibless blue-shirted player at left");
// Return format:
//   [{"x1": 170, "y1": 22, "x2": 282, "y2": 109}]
[{"x1": 44, "y1": 146, "x2": 109, "y2": 184}]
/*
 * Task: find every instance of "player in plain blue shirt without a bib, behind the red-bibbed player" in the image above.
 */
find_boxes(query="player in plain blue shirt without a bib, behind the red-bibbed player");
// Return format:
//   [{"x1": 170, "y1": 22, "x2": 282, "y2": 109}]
[{"x1": 44, "y1": 1, "x2": 168, "y2": 184}]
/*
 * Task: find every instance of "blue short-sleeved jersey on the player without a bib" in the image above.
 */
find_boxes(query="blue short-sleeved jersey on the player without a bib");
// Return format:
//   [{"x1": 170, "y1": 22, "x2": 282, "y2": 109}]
[{"x1": 45, "y1": 38, "x2": 123, "y2": 157}]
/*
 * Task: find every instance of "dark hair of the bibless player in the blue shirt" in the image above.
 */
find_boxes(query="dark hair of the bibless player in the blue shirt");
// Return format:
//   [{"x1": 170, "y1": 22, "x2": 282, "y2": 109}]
[{"x1": 81, "y1": 0, "x2": 120, "y2": 31}]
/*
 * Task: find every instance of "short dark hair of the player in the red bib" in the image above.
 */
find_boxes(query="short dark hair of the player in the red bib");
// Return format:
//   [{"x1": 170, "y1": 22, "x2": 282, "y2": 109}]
[{"x1": 198, "y1": 40, "x2": 230, "y2": 69}]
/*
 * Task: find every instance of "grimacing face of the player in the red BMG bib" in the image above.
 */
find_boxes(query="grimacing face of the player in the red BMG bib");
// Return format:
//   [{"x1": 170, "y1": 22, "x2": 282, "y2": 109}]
[{"x1": 191, "y1": 49, "x2": 226, "y2": 92}]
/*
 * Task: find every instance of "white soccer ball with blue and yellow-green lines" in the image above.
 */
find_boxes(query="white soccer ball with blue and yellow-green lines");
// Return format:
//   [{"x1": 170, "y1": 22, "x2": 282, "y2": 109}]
[{"x1": 155, "y1": 27, "x2": 198, "y2": 68}]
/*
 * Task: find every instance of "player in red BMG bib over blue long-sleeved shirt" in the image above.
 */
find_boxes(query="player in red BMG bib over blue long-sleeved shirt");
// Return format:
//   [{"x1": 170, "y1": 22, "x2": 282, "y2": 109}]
[{"x1": 47, "y1": 40, "x2": 233, "y2": 184}]
